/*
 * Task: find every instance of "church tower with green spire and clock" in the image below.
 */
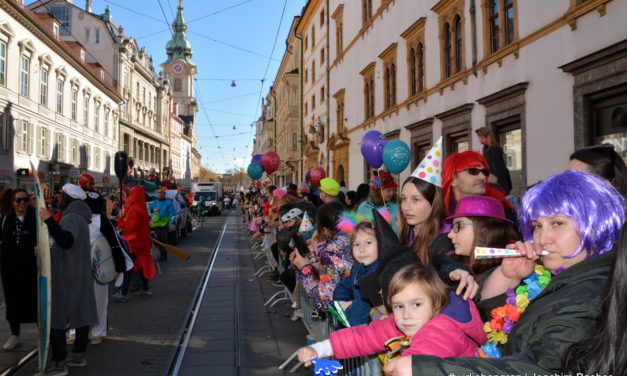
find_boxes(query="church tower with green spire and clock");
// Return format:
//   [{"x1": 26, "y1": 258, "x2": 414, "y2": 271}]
[{"x1": 161, "y1": 0, "x2": 198, "y2": 141}]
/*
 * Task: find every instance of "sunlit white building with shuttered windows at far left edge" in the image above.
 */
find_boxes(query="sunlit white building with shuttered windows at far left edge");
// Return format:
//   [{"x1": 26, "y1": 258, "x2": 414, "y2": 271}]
[{"x1": 0, "y1": 0, "x2": 122, "y2": 191}]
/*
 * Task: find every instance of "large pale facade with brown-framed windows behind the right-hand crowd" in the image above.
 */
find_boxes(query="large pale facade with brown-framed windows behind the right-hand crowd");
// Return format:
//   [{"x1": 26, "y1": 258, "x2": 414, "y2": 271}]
[{"x1": 328, "y1": 0, "x2": 627, "y2": 194}]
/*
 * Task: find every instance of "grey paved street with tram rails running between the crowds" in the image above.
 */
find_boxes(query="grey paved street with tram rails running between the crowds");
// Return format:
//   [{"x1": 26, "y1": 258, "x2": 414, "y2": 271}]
[{"x1": 0, "y1": 212, "x2": 310, "y2": 376}]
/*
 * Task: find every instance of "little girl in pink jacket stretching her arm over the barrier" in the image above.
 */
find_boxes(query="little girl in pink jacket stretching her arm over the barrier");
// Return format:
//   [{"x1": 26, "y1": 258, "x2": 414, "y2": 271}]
[{"x1": 298, "y1": 264, "x2": 486, "y2": 366}]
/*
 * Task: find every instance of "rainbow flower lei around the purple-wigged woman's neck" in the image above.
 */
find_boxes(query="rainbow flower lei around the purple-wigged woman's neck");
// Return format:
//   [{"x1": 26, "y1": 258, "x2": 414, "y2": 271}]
[{"x1": 475, "y1": 265, "x2": 551, "y2": 358}]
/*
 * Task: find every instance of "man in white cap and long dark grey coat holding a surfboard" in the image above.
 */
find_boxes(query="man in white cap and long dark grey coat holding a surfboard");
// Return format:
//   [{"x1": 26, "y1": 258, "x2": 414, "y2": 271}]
[{"x1": 39, "y1": 184, "x2": 98, "y2": 375}]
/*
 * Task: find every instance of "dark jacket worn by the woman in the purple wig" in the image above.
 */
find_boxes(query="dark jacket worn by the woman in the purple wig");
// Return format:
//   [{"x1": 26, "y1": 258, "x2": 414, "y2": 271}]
[{"x1": 412, "y1": 251, "x2": 612, "y2": 375}]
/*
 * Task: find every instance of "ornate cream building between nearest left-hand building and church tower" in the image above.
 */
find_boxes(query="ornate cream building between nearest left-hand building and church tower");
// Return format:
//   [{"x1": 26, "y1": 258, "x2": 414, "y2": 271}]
[{"x1": 29, "y1": 0, "x2": 171, "y2": 182}]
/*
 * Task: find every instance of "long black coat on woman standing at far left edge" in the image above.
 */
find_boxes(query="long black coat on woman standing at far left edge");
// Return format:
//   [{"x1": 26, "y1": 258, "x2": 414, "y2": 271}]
[{"x1": 0, "y1": 208, "x2": 37, "y2": 323}]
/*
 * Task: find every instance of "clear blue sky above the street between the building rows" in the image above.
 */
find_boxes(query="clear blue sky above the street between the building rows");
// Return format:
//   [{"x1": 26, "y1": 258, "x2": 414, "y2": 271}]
[{"x1": 74, "y1": 0, "x2": 306, "y2": 173}]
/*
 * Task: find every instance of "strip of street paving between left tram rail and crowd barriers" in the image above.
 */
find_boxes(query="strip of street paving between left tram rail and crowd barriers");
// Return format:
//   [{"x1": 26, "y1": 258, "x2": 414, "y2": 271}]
[{"x1": 179, "y1": 215, "x2": 312, "y2": 376}]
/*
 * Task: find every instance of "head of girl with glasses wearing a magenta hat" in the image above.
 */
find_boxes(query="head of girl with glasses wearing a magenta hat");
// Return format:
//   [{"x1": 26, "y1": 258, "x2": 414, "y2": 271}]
[{"x1": 446, "y1": 196, "x2": 519, "y2": 278}]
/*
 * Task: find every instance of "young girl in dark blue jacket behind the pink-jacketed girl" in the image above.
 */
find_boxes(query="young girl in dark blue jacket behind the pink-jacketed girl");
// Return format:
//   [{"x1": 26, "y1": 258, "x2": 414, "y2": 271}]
[{"x1": 333, "y1": 221, "x2": 379, "y2": 326}]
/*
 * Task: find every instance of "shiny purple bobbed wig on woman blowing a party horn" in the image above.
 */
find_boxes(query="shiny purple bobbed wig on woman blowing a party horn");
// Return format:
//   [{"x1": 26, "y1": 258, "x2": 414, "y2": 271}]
[{"x1": 519, "y1": 170, "x2": 625, "y2": 258}]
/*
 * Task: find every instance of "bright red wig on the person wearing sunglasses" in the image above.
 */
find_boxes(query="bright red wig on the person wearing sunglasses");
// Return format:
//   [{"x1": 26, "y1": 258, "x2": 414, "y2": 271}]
[{"x1": 442, "y1": 150, "x2": 514, "y2": 214}]
